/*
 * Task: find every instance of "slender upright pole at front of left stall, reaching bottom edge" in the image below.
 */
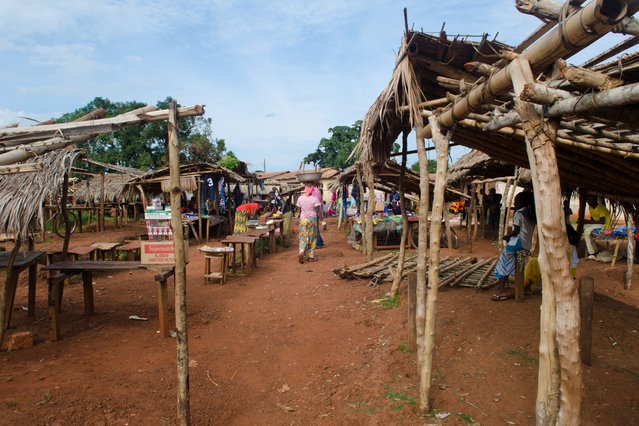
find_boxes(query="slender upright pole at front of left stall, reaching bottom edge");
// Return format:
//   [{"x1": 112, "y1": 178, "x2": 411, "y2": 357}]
[{"x1": 168, "y1": 100, "x2": 191, "y2": 426}]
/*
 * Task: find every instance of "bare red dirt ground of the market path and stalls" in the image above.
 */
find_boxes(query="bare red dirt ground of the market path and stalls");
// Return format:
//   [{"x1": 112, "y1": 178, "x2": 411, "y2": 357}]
[{"x1": 0, "y1": 221, "x2": 639, "y2": 425}]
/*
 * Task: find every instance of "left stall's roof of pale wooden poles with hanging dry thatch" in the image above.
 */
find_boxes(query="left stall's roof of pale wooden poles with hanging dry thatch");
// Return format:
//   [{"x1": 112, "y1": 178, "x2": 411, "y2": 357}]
[{"x1": 0, "y1": 105, "x2": 204, "y2": 241}]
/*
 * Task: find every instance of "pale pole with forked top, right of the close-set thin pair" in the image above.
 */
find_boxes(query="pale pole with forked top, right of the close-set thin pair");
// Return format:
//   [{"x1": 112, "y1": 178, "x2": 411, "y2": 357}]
[{"x1": 419, "y1": 116, "x2": 452, "y2": 411}]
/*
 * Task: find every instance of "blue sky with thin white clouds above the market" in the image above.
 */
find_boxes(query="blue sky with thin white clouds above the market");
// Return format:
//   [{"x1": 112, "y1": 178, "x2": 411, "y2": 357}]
[{"x1": 0, "y1": 0, "x2": 632, "y2": 171}]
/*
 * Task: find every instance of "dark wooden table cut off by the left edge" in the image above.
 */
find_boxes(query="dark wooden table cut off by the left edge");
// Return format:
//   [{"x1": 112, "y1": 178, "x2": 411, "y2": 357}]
[{"x1": 0, "y1": 251, "x2": 46, "y2": 327}]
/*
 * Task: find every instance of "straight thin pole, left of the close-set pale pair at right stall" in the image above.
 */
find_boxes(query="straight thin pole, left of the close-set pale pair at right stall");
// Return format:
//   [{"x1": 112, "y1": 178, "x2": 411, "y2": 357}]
[{"x1": 415, "y1": 123, "x2": 430, "y2": 372}]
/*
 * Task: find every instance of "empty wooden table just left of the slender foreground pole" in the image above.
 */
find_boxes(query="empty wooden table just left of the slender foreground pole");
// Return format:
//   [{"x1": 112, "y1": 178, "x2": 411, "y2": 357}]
[{"x1": 43, "y1": 260, "x2": 175, "y2": 341}]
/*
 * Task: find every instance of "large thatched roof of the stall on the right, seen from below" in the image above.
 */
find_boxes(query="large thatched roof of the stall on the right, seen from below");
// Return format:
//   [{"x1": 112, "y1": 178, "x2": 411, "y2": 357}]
[{"x1": 354, "y1": 0, "x2": 639, "y2": 205}]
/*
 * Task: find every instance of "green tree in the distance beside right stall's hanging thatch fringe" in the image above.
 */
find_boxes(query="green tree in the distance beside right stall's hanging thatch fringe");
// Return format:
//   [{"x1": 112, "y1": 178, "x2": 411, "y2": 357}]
[{"x1": 304, "y1": 121, "x2": 362, "y2": 169}]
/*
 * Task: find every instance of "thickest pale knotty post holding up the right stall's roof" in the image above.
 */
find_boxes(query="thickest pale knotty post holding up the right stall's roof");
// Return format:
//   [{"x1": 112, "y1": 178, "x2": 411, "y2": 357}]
[{"x1": 508, "y1": 57, "x2": 583, "y2": 426}]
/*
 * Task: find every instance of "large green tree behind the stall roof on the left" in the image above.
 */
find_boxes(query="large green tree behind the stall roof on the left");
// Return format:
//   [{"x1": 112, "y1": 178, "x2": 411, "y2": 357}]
[{"x1": 58, "y1": 97, "x2": 232, "y2": 170}]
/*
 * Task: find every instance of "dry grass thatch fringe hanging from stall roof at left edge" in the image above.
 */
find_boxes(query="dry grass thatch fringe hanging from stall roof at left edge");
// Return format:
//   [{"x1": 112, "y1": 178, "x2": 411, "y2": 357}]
[{"x1": 0, "y1": 149, "x2": 80, "y2": 241}]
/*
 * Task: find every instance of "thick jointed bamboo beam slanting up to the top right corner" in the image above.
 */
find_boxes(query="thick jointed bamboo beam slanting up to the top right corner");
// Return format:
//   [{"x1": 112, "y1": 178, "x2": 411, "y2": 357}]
[{"x1": 424, "y1": 0, "x2": 627, "y2": 137}]
